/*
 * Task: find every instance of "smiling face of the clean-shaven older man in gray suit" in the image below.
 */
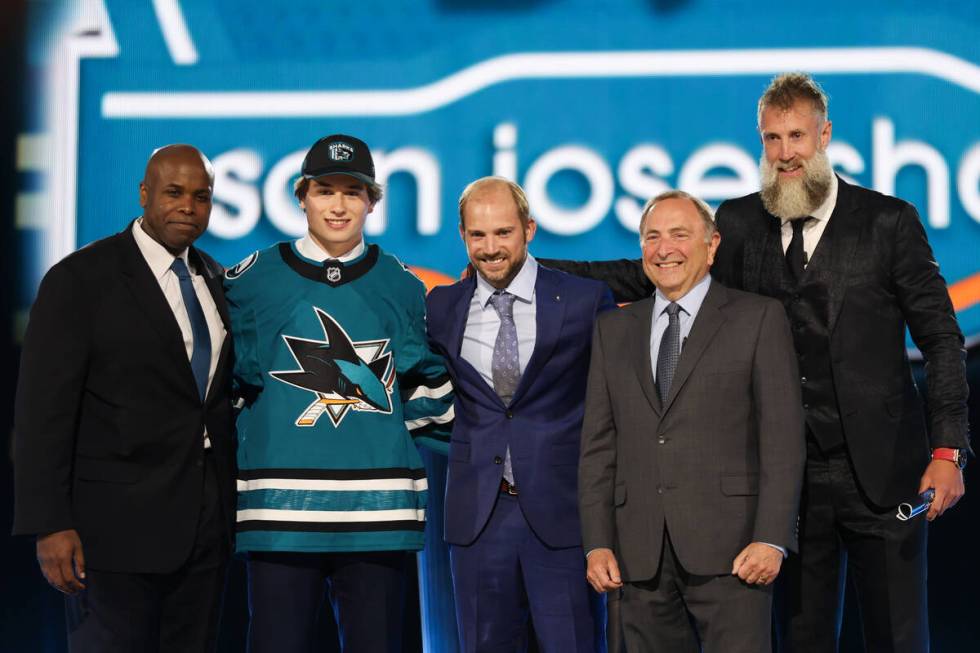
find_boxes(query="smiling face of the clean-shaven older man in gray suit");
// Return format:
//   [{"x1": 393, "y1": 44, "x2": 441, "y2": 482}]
[{"x1": 640, "y1": 198, "x2": 721, "y2": 301}]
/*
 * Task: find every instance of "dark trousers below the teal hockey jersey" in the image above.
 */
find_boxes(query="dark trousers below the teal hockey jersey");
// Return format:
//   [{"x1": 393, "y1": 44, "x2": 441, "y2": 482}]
[{"x1": 247, "y1": 551, "x2": 408, "y2": 653}]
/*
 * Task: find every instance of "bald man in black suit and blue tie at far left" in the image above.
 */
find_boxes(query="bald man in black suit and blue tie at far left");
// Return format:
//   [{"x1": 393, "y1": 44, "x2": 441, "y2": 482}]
[{"x1": 14, "y1": 145, "x2": 235, "y2": 652}]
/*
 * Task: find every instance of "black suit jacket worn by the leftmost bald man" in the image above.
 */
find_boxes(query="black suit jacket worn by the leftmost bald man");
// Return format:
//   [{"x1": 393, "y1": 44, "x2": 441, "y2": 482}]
[{"x1": 14, "y1": 225, "x2": 235, "y2": 573}]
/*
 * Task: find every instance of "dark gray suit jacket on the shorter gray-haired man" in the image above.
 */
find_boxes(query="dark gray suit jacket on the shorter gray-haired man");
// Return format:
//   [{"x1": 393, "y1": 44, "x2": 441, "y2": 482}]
[{"x1": 579, "y1": 281, "x2": 806, "y2": 581}]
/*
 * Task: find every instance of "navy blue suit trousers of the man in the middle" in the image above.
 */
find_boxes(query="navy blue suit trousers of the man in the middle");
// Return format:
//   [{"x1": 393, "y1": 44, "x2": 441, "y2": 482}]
[{"x1": 449, "y1": 494, "x2": 605, "y2": 653}]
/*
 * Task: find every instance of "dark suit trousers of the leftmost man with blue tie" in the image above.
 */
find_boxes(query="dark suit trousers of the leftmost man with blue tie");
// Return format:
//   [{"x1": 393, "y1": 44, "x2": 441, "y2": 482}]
[{"x1": 65, "y1": 453, "x2": 229, "y2": 653}]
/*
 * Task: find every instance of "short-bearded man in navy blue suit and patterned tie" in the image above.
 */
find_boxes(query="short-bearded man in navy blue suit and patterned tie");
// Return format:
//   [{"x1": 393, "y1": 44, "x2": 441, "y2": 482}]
[{"x1": 428, "y1": 177, "x2": 614, "y2": 653}]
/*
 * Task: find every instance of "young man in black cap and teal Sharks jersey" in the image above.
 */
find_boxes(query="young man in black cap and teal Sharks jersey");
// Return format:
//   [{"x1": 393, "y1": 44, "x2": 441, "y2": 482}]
[{"x1": 225, "y1": 134, "x2": 453, "y2": 653}]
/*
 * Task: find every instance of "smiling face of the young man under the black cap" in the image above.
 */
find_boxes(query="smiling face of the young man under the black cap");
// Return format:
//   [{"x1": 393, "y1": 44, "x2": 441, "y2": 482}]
[{"x1": 299, "y1": 175, "x2": 374, "y2": 257}]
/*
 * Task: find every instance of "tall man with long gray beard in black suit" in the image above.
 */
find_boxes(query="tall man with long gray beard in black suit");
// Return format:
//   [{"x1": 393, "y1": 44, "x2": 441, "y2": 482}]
[{"x1": 543, "y1": 74, "x2": 969, "y2": 652}]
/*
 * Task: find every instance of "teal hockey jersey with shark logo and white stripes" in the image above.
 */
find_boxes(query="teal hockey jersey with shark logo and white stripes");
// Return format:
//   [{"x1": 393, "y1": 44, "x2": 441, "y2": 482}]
[{"x1": 225, "y1": 242, "x2": 453, "y2": 552}]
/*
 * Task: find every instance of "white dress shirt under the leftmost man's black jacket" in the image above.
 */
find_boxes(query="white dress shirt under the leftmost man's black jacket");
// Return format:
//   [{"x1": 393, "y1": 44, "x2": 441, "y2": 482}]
[{"x1": 133, "y1": 218, "x2": 227, "y2": 447}]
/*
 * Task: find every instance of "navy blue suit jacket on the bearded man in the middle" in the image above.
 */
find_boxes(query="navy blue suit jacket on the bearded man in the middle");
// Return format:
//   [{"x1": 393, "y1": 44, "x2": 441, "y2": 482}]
[{"x1": 427, "y1": 266, "x2": 615, "y2": 547}]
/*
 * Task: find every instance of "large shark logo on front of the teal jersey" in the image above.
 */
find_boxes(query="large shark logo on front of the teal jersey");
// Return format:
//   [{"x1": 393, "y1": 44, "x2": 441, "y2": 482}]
[{"x1": 269, "y1": 307, "x2": 395, "y2": 427}]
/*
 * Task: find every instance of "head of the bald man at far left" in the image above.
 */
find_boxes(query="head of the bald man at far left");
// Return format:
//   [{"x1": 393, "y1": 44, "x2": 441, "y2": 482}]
[{"x1": 140, "y1": 146, "x2": 213, "y2": 256}]
